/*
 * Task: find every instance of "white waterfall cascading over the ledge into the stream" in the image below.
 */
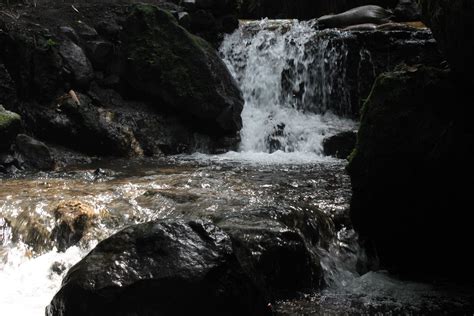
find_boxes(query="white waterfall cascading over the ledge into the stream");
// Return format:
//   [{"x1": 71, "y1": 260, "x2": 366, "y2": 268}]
[{"x1": 220, "y1": 20, "x2": 355, "y2": 155}]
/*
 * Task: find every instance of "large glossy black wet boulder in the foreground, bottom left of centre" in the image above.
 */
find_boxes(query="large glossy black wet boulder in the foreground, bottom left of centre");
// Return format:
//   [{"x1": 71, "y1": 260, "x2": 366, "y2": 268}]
[{"x1": 46, "y1": 220, "x2": 267, "y2": 315}]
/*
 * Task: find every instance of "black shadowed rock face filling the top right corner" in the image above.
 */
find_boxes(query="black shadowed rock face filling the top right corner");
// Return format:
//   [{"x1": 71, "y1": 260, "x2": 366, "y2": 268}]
[{"x1": 420, "y1": 0, "x2": 474, "y2": 86}]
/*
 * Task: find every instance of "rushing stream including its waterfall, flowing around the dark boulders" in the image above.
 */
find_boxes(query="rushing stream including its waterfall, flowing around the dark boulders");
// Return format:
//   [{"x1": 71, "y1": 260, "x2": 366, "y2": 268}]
[{"x1": 0, "y1": 21, "x2": 472, "y2": 316}]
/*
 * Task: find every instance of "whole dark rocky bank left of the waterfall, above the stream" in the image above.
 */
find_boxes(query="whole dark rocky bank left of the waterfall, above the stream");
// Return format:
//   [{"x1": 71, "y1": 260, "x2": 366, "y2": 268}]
[{"x1": 0, "y1": 1, "x2": 243, "y2": 160}]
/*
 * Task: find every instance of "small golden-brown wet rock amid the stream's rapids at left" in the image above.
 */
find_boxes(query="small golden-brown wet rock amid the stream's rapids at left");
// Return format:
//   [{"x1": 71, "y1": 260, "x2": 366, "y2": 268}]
[{"x1": 51, "y1": 200, "x2": 97, "y2": 251}]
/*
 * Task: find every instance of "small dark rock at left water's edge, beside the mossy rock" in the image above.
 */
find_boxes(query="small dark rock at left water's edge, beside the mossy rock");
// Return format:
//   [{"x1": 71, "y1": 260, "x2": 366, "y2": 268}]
[{"x1": 15, "y1": 134, "x2": 55, "y2": 170}]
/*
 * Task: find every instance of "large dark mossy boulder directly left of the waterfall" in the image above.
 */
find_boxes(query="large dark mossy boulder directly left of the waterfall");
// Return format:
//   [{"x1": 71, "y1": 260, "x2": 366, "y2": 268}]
[{"x1": 122, "y1": 5, "x2": 243, "y2": 134}]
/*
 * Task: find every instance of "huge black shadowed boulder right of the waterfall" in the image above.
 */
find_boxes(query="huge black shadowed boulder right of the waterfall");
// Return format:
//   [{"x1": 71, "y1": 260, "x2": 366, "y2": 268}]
[{"x1": 348, "y1": 66, "x2": 474, "y2": 279}]
